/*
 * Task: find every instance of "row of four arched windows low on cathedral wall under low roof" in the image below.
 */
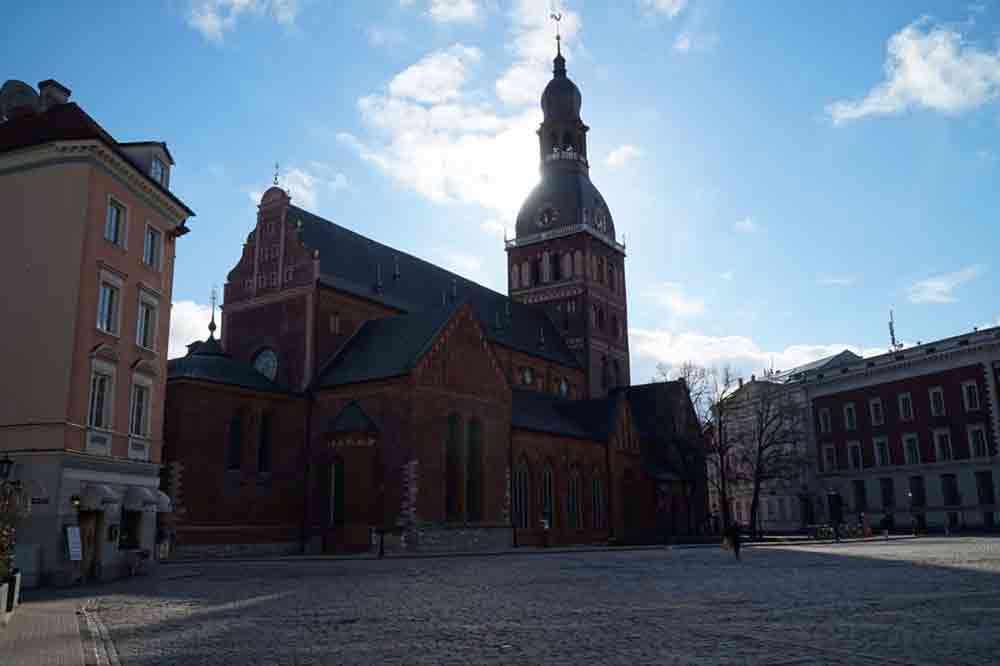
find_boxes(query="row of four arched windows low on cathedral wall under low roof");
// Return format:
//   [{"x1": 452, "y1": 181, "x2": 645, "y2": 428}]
[{"x1": 512, "y1": 460, "x2": 607, "y2": 529}]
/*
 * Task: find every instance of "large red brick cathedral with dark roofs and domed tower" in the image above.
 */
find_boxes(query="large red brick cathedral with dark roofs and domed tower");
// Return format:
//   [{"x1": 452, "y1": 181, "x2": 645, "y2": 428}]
[{"x1": 163, "y1": 48, "x2": 707, "y2": 553}]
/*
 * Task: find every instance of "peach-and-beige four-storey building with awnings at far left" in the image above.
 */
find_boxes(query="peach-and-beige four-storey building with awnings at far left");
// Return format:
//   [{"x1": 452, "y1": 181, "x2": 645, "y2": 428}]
[{"x1": 0, "y1": 80, "x2": 193, "y2": 584}]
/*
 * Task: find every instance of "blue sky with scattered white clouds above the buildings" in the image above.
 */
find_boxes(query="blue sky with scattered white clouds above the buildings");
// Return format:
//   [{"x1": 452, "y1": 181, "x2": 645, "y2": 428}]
[{"x1": 0, "y1": 0, "x2": 1000, "y2": 383}]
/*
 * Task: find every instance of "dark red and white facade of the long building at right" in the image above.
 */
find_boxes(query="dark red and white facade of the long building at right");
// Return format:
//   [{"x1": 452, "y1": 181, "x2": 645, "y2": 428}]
[{"x1": 808, "y1": 328, "x2": 1000, "y2": 530}]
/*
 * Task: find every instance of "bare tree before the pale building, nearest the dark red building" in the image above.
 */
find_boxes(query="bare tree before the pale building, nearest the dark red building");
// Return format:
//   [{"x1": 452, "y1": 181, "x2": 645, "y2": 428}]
[{"x1": 726, "y1": 381, "x2": 809, "y2": 537}]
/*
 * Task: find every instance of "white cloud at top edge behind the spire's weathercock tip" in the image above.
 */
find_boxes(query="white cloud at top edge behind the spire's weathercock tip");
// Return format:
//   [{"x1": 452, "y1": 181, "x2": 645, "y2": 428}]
[{"x1": 496, "y1": 0, "x2": 581, "y2": 105}]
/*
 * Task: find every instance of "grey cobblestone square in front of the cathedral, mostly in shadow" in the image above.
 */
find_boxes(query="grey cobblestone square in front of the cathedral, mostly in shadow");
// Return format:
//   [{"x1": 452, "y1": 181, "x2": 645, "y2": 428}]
[{"x1": 82, "y1": 538, "x2": 1000, "y2": 666}]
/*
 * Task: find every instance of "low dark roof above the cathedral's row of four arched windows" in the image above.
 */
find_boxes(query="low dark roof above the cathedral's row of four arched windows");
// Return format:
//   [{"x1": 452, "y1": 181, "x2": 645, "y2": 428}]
[{"x1": 511, "y1": 389, "x2": 618, "y2": 442}]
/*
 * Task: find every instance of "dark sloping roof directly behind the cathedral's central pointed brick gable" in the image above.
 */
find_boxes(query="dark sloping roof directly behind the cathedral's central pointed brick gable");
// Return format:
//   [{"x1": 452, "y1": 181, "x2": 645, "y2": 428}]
[{"x1": 313, "y1": 304, "x2": 459, "y2": 388}]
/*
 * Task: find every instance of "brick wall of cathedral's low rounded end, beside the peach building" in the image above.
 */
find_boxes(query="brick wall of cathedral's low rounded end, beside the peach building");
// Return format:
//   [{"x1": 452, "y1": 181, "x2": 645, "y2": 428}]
[{"x1": 164, "y1": 381, "x2": 305, "y2": 545}]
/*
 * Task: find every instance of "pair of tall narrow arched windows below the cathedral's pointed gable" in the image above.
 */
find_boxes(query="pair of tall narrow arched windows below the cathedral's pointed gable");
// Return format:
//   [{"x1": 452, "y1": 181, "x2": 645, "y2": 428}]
[{"x1": 445, "y1": 414, "x2": 483, "y2": 522}]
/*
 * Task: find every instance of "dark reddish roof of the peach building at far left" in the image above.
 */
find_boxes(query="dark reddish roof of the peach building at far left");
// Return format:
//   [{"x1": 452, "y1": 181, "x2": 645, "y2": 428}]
[{"x1": 0, "y1": 102, "x2": 194, "y2": 216}]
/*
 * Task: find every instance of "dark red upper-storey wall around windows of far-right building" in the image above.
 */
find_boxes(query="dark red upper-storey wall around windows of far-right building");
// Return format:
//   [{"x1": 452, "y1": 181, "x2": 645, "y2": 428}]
[{"x1": 813, "y1": 364, "x2": 997, "y2": 471}]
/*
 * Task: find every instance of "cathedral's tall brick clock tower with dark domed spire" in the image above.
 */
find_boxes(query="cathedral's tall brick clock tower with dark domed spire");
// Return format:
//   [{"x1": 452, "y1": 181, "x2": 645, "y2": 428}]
[{"x1": 507, "y1": 42, "x2": 629, "y2": 397}]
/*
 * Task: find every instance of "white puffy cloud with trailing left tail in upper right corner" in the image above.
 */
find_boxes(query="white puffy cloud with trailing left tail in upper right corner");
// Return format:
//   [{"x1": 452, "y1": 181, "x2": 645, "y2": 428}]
[{"x1": 826, "y1": 19, "x2": 1000, "y2": 125}]
